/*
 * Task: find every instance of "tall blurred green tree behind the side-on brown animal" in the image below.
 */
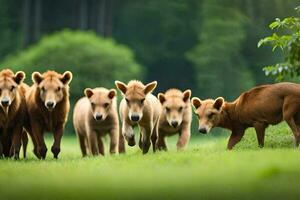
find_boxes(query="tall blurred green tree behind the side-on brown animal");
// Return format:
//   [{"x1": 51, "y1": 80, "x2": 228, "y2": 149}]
[{"x1": 187, "y1": 0, "x2": 252, "y2": 97}]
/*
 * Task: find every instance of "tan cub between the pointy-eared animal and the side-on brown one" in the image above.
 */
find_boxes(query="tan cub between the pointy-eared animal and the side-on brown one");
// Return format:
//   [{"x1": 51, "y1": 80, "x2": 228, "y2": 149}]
[{"x1": 156, "y1": 89, "x2": 192, "y2": 150}]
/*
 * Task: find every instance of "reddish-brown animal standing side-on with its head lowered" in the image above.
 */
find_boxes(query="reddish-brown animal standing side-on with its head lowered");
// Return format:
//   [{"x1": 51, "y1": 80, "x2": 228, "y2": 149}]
[{"x1": 192, "y1": 82, "x2": 300, "y2": 149}]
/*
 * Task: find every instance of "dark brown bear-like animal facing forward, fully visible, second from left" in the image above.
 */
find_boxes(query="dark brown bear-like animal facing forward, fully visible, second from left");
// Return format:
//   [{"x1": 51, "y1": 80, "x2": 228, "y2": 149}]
[{"x1": 26, "y1": 71, "x2": 72, "y2": 159}]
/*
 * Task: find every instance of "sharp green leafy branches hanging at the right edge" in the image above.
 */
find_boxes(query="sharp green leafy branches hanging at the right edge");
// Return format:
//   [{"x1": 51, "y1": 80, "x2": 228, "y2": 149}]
[{"x1": 258, "y1": 6, "x2": 300, "y2": 81}]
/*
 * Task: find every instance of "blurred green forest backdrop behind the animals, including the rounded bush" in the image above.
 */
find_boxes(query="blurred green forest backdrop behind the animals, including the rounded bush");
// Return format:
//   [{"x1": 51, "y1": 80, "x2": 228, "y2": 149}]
[{"x1": 0, "y1": 0, "x2": 299, "y2": 134}]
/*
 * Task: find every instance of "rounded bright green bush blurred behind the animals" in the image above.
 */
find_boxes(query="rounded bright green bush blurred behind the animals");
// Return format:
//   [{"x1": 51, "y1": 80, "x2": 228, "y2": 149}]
[{"x1": 1, "y1": 30, "x2": 142, "y2": 98}]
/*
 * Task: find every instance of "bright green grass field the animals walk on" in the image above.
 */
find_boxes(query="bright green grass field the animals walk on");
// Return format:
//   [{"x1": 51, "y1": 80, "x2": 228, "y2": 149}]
[{"x1": 0, "y1": 124, "x2": 300, "y2": 200}]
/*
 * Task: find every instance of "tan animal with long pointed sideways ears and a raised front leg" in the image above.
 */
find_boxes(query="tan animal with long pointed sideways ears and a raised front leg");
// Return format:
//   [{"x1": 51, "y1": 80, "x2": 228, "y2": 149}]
[{"x1": 115, "y1": 80, "x2": 161, "y2": 154}]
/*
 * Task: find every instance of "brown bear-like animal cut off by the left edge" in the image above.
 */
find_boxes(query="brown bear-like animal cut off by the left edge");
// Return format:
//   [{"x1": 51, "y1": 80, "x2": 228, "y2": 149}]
[{"x1": 0, "y1": 69, "x2": 26, "y2": 159}]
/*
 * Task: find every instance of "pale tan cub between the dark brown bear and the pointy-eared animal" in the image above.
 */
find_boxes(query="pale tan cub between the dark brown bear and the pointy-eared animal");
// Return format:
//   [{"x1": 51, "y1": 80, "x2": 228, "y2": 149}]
[{"x1": 73, "y1": 87, "x2": 124, "y2": 157}]
